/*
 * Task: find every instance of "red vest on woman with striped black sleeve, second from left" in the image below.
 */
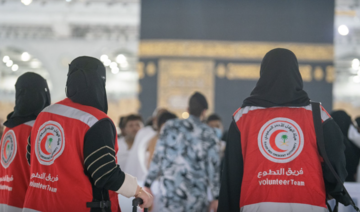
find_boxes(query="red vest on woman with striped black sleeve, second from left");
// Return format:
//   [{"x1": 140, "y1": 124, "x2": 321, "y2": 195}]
[{"x1": 24, "y1": 98, "x2": 120, "y2": 212}]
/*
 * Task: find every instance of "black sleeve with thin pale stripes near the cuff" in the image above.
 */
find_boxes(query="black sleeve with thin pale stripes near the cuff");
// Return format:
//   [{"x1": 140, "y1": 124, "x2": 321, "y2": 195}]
[{"x1": 84, "y1": 119, "x2": 125, "y2": 191}]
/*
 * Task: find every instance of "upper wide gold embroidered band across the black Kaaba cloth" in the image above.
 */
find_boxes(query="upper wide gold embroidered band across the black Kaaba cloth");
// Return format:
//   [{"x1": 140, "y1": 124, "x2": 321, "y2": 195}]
[{"x1": 139, "y1": 40, "x2": 334, "y2": 62}]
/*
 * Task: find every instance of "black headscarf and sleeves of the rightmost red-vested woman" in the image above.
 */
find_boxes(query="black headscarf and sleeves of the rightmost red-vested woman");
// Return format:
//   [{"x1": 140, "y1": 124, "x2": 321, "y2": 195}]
[{"x1": 218, "y1": 48, "x2": 346, "y2": 212}]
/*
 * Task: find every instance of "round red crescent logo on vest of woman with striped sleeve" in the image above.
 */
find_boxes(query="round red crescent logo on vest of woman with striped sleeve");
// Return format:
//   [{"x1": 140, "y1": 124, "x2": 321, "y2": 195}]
[{"x1": 35, "y1": 121, "x2": 65, "y2": 165}]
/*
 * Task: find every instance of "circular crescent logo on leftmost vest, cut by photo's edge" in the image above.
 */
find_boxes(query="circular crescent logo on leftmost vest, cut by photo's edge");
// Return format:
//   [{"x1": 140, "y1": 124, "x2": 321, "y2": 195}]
[{"x1": 1, "y1": 130, "x2": 17, "y2": 169}]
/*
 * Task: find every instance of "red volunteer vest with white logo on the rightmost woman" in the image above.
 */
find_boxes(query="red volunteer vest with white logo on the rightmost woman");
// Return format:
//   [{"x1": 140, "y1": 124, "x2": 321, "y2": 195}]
[{"x1": 234, "y1": 105, "x2": 330, "y2": 211}]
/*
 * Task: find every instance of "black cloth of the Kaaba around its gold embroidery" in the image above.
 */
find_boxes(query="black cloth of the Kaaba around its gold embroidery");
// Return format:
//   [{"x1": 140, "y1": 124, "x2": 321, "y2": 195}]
[{"x1": 139, "y1": 0, "x2": 335, "y2": 128}]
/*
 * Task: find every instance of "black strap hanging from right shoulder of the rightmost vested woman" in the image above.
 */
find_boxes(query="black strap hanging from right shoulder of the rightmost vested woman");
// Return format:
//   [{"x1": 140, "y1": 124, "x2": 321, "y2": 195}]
[{"x1": 311, "y1": 102, "x2": 360, "y2": 211}]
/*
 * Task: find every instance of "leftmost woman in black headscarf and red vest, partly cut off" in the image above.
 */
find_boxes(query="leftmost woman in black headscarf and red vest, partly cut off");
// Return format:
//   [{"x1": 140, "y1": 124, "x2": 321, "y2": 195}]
[{"x1": 0, "y1": 72, "x2": 51, "y2": 212}]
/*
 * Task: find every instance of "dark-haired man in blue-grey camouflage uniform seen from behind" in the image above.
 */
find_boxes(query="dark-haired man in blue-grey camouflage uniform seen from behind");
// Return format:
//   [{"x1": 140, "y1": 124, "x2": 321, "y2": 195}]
[{"x1": 145, "y1": 92, "x2": 220, "y2": 212}]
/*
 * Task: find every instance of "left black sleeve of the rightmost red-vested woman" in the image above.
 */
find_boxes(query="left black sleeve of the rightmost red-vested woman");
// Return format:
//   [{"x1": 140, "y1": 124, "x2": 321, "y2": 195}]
[{"x1": 218, "y1": 121, "x2": 244, "y2": 212}]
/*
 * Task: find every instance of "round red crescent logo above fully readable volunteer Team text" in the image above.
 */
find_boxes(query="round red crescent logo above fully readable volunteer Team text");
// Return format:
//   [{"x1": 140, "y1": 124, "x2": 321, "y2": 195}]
[{"x1": 258, "y1": 118, "x2": 304, "y2": 163}]
